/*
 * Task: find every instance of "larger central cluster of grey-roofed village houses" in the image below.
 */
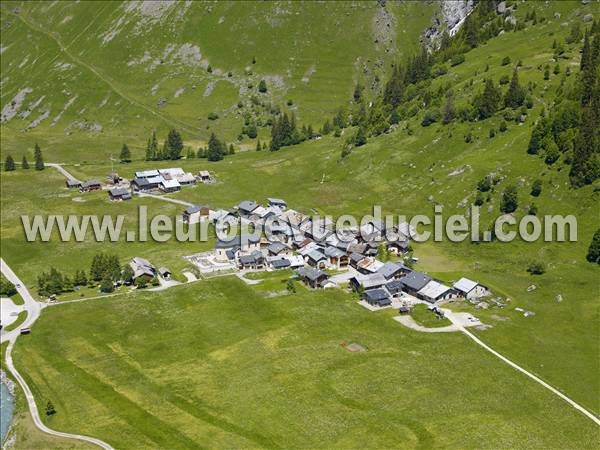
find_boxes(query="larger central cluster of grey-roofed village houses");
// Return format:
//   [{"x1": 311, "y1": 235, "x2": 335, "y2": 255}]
[{"x1": 183, "y1": 198, "x2": 489, "y2": 309}]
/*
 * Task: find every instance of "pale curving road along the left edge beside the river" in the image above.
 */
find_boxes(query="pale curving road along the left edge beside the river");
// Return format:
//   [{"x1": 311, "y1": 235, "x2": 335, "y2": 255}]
[{"x1": 0, "y1": 258, "x2": 114, "y2": 450}]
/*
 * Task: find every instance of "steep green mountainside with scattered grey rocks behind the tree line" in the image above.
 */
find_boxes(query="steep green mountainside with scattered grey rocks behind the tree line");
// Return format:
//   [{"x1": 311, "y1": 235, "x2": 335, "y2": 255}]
[{"x1": 0, "y1": 1, "x2": 438, "y2": 160}]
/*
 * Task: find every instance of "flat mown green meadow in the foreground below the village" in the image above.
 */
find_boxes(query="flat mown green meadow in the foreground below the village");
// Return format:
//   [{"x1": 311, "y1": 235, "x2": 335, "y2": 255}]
[{"x1": 14, "y1": 277, "x2": 598, "y2": 448}]
